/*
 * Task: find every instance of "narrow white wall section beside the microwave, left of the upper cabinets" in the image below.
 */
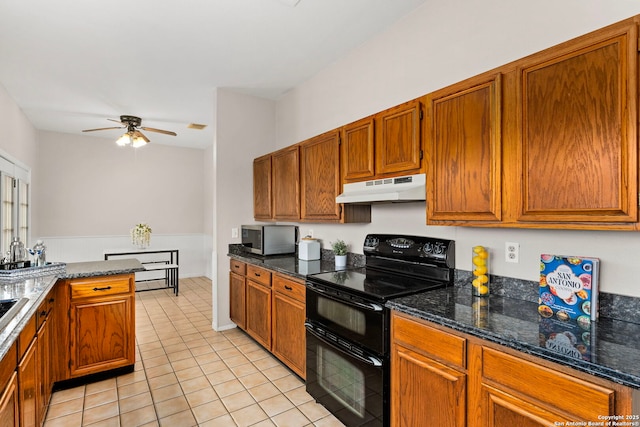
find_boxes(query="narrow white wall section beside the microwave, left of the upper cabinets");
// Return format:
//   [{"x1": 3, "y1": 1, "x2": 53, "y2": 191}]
[{"x1": 212, "y1": 89, "x2": 275, "y2": 330}]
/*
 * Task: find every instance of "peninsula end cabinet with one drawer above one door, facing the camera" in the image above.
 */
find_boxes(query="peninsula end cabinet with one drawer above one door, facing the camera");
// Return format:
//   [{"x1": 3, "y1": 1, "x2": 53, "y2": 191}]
[{"x1": 63, "y1": 274, "x2": 135, "y2": 378}]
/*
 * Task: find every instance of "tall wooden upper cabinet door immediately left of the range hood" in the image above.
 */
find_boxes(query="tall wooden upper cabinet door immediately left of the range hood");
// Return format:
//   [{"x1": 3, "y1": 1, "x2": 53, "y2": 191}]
[{"x1": 300, "y1": 130, "x2": 340, "y2": 221}]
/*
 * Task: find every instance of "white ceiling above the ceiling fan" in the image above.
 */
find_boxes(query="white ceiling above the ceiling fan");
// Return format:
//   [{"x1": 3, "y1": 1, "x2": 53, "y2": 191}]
[{"x1": 0, "y1": 0, "x2": 425, "y2": 148}]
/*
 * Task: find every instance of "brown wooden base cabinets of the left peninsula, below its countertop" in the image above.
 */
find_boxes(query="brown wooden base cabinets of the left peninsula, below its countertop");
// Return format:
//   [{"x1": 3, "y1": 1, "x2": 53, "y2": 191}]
[{"x1": 0, "y1": 274, "x2": 135, "y2": 427}]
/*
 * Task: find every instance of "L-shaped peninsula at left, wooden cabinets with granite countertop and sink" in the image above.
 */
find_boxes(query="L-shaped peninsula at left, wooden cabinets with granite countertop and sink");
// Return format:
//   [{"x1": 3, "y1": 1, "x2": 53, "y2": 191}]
[{"x1": 0, "y1": 259, "x2": 144, "y2": 425}]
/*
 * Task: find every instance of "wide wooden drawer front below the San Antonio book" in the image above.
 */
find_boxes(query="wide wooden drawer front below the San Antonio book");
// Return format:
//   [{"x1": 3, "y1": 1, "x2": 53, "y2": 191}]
[{"x1": 482, "y1": 347, "x2": 615, "y2": 420}]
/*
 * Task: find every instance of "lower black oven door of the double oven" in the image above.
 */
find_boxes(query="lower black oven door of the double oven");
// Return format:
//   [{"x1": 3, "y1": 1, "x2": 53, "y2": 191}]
[{"x1": 305, "y1": 322, "x2": 389, "y2": 427}]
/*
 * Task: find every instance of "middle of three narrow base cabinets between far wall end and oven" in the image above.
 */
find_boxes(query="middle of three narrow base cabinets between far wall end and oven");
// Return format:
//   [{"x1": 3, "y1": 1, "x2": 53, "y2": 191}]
[{"x1": 246, "y1": 265, "x2": 271, "y2": 351}]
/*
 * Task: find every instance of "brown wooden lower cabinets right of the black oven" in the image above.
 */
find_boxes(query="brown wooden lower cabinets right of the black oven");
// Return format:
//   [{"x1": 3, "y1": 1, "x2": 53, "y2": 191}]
[{"x1": 391, "y1": 312, "x2": 638, "y2": 427}]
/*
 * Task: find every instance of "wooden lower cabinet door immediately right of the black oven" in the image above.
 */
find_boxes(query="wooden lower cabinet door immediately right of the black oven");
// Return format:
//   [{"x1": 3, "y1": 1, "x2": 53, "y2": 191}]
[{"x1": 391, "y1": 345, "x2": 464, "y2": 427}]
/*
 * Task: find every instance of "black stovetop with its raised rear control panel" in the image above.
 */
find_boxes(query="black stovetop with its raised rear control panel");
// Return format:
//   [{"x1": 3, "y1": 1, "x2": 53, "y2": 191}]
[{"x1": 307, "y1": 234, "x2": 455, "y2": 301}]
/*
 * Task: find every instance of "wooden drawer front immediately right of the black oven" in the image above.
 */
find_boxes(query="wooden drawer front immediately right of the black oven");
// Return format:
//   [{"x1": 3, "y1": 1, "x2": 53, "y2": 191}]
[{"x1": 392, "y1": 313, "x2": 467, "y2": 368}]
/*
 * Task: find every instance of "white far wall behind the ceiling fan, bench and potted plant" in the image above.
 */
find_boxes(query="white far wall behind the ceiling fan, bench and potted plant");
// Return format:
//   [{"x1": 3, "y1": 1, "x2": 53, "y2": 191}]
[{"x1": 32, "y1": 131, "x2": 210, "y2": 277}]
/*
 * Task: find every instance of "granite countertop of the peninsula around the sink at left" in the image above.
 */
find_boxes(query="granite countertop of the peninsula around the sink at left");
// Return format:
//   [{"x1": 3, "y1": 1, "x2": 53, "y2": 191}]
[{"x1": 0, "y1": 259, "x2": 144, "y2": 359}]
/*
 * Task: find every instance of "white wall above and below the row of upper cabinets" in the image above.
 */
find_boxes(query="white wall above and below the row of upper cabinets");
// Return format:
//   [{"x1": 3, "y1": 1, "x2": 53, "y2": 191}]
[{"x1": 277, "y1": 0, "x2": 640, "y2": 297}]
